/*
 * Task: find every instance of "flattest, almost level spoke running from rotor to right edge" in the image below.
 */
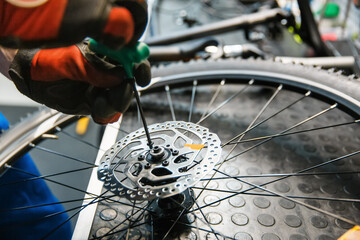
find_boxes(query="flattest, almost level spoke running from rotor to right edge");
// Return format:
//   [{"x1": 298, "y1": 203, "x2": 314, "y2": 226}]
[{"x1": 200, "y1": 171, "x2": 360, "y2": 181}]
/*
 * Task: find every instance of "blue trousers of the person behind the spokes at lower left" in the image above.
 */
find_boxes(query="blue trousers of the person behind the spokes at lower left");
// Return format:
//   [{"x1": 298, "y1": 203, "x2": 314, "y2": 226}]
[{"x1": 0, "y1": 113, "x2": 72, "y2": 240}]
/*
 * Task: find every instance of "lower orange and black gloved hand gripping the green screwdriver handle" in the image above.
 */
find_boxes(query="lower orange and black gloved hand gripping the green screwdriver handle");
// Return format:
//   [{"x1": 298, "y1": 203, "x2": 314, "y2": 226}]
[{"x1": 9, "y1": 42, "x2": 151, "y2": 124}]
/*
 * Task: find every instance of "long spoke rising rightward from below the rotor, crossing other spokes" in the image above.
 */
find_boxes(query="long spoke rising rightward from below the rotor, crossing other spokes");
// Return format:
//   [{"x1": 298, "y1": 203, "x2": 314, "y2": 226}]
[{"x1": 191, "y1": 150, "x2": 360, "y2": 212}]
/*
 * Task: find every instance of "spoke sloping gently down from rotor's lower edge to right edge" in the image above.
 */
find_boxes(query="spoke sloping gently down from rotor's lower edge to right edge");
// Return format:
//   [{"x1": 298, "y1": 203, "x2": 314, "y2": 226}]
[{"x1": 192, "y1": 187, "x2": 360, "y2": 203}]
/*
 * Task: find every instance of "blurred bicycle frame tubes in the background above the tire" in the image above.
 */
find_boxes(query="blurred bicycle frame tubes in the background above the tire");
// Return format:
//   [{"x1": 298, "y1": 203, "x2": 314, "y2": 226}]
[{"x1": 145, "y1": 0, "x2": 333, "y2": 62}]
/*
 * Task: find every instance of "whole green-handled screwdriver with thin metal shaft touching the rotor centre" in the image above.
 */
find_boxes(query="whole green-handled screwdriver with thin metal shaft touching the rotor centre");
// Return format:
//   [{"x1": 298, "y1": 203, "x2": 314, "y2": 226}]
[{"x1": 88, "y1": 39, "x2": 153, "y2": 149}]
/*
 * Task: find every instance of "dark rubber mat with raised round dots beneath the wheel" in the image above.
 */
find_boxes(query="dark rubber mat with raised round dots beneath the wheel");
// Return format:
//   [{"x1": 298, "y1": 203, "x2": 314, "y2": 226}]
[{"x1": 91, "y1": 86, "x2": 360, "y2": 240}]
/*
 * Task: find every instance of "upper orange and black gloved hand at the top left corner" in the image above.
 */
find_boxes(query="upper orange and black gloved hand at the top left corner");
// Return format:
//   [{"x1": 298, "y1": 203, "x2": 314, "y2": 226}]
[{"x1": 0, "y1": 0, "x2": 147, "y2": 48}]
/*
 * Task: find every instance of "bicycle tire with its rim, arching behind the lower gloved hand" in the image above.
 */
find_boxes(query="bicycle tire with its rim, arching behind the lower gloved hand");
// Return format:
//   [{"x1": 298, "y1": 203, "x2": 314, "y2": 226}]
[{"x1": 0, "y1": 59, "x2": 360, "y2": 239}]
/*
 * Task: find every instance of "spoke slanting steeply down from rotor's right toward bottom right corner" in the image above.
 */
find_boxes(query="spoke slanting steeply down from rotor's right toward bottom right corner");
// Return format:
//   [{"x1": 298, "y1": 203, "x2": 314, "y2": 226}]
[{"x1": 218, "y1": 171, "x2": 357, "y2": 225}]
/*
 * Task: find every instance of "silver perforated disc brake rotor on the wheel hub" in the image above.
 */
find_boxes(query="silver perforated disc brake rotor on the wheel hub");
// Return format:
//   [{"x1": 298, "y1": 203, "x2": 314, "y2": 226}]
[{"x1": 98, "y1": 121, "x2": 221, "y2": 200}]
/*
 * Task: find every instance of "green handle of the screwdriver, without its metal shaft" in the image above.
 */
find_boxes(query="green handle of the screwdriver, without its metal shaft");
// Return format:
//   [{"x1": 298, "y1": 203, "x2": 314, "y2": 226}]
[{"x1": 89, "y1": 38, "x2": 150, "y2": 78}]
